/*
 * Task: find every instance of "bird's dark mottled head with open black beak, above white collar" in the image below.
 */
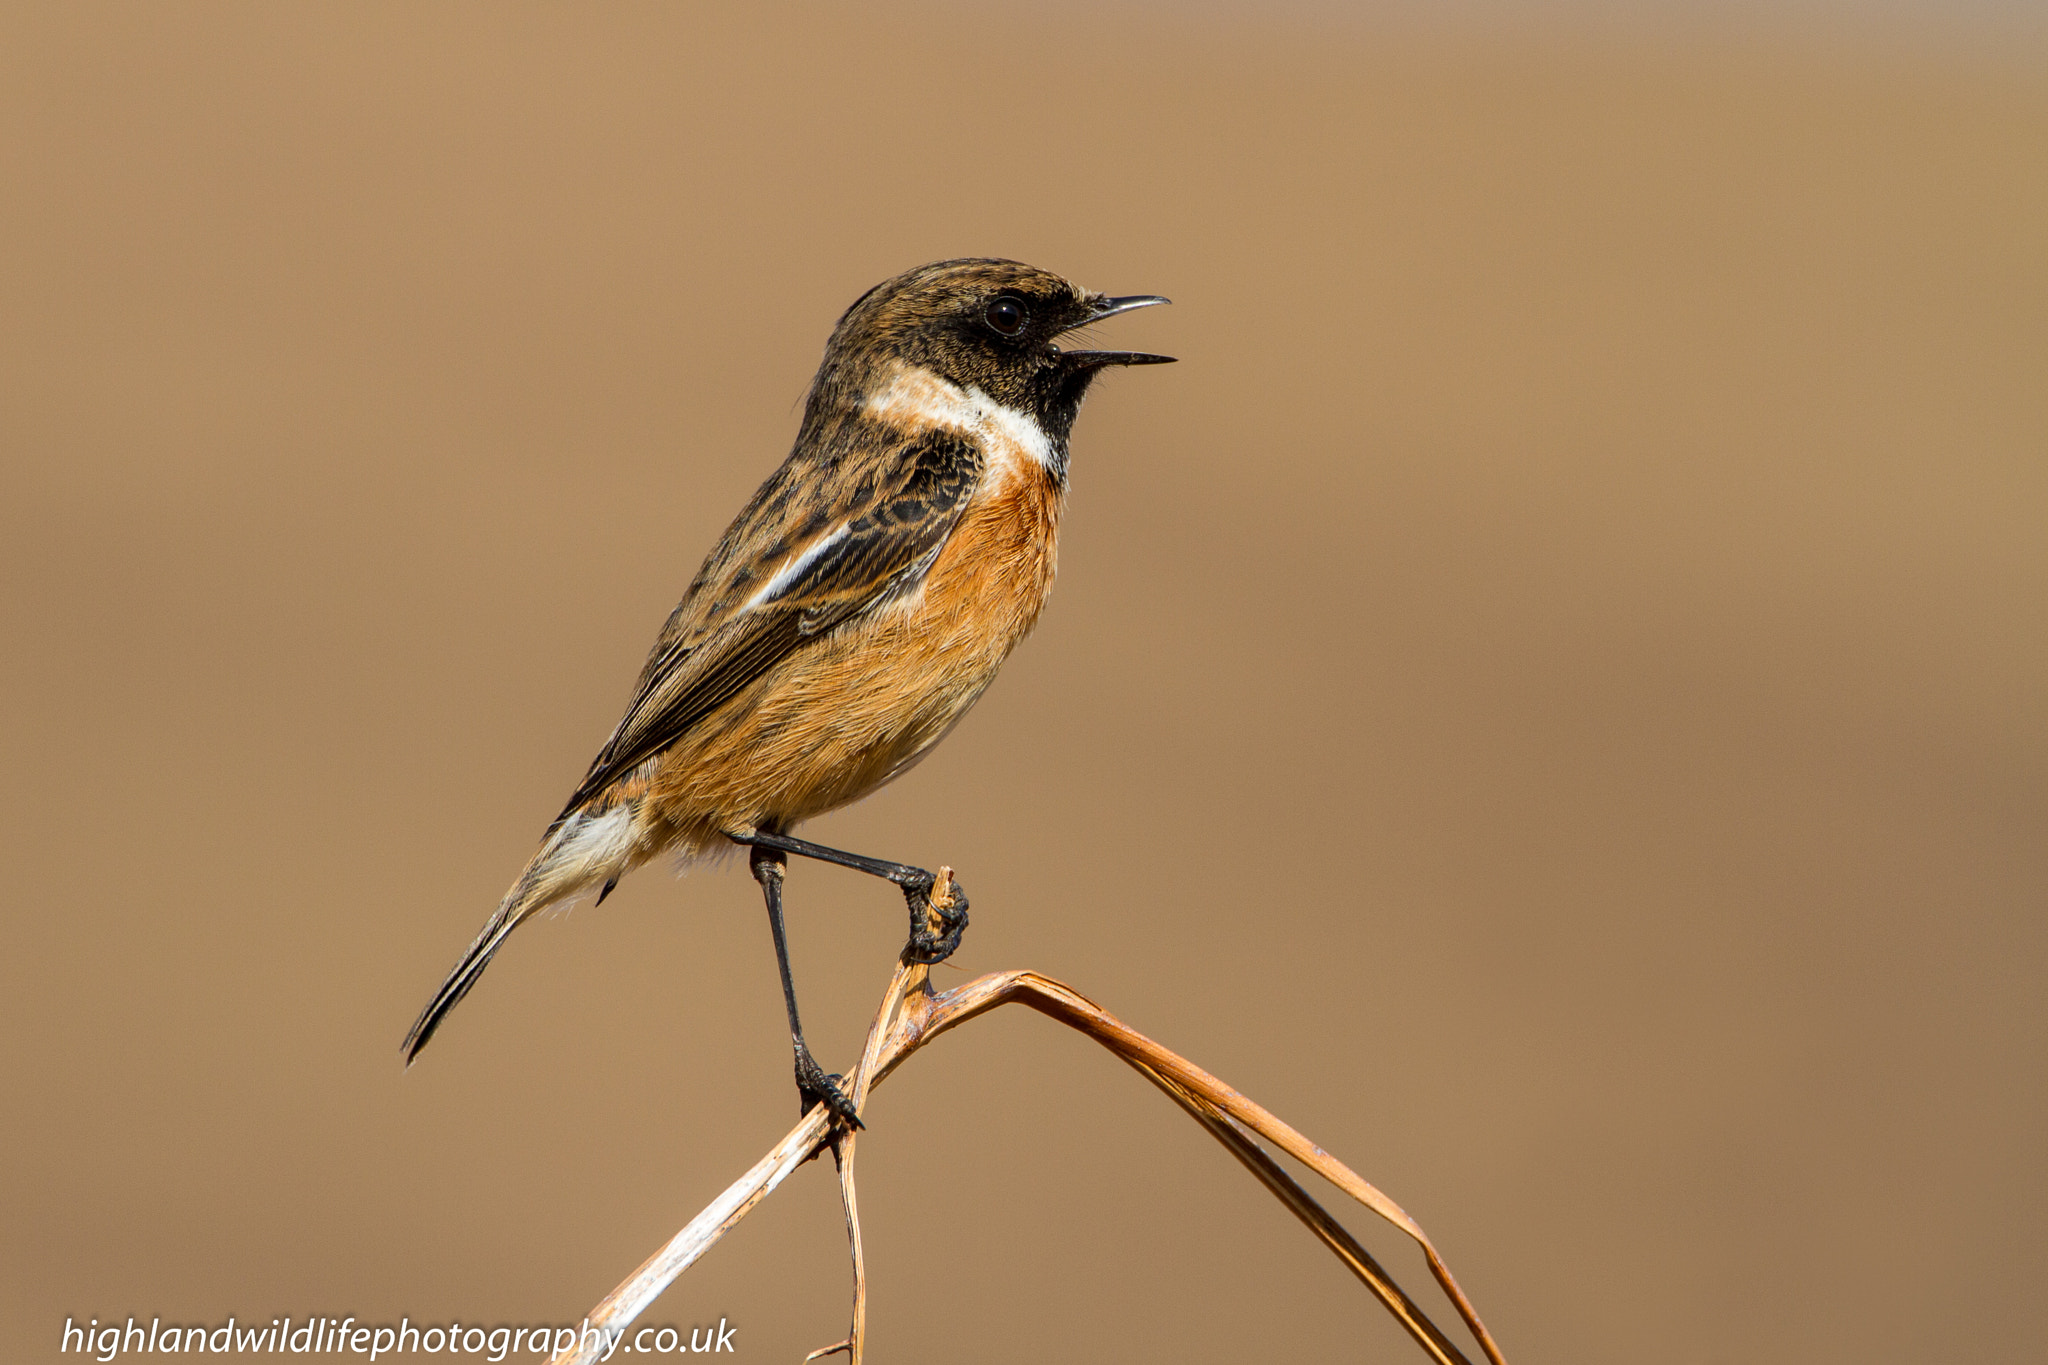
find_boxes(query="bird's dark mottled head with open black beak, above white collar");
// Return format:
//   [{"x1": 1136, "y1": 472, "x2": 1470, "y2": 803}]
[{"x1": 811, "y1": 260, "x2": 1174, "y2": 438}]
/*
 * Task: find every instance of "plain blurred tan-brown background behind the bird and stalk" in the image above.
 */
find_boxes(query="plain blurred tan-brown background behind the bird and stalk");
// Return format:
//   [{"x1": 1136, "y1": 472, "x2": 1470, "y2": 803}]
[{"x1": 0, "y1": 4, "x2": 2048, "y2": 1365}]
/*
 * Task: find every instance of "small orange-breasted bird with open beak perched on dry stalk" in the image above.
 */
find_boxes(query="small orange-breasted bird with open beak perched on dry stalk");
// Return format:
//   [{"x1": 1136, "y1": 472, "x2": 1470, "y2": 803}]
[{"x1": 403, "y1": 260, "x2": 1171, "y2": 1126}]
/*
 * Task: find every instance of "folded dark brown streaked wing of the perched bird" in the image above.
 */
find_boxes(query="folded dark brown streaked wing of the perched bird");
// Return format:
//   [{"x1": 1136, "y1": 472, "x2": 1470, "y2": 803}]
[{"x1": 555, "y1": 430, "x2": 981, "y2": 825}]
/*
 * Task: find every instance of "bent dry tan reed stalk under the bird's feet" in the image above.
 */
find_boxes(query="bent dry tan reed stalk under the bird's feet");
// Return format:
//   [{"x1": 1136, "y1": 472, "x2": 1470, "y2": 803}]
[{"x1": 551, "y1": 868, "x2": 1507, "y2": 1365}]
